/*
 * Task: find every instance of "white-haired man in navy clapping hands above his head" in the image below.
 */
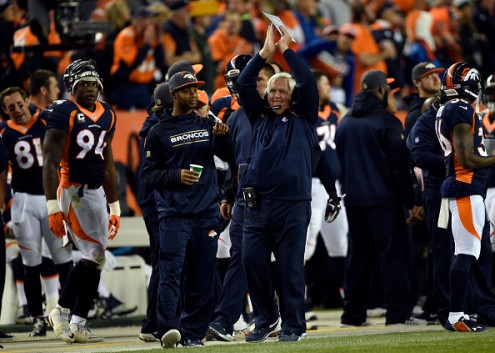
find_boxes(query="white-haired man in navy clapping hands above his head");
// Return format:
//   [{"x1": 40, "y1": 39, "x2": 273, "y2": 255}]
[{"x1": 237, "y1": 25, "x2": 321, "y2": 342}]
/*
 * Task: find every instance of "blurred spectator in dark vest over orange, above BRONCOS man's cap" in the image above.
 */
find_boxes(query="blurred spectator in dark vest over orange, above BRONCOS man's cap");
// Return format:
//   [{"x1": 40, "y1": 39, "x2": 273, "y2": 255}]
[{"x1": 163, "y1": 0, "x2": 201, "y2": 71}]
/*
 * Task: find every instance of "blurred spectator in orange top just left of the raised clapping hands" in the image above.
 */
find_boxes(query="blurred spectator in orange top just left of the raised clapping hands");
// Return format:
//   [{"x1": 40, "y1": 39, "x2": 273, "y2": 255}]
[{"x1": 208, "y1": 10, "x2": 253, "y2": 89}]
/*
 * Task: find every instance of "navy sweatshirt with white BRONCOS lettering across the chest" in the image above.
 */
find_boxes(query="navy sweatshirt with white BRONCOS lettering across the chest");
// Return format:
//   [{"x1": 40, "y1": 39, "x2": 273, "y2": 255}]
[{"x1": 142, "y1": 110, "x2": 230, "y2": 218}]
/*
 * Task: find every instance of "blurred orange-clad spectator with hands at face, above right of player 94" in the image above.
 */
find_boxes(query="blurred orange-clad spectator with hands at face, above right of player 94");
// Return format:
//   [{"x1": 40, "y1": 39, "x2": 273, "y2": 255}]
[{"x1": 110, "y1": 6, "x2": 165, "y2": 109}]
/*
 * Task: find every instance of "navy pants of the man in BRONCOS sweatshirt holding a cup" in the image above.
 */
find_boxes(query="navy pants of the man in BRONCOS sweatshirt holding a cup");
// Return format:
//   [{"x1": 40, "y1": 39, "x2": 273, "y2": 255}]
[{"x1": 157, "y1": 217, "x2": 218, "y2": 340}]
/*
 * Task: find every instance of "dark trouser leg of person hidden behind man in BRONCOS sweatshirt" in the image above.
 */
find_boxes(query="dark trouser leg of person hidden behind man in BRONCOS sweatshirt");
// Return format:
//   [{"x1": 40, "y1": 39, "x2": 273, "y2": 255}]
[{"x1": 141, "y1": 211, "x2": 160, "y2": 333}]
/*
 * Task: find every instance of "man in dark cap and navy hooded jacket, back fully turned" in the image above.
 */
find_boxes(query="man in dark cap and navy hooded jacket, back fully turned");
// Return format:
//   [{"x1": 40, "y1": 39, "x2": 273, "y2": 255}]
[{"x1": 335, "y1": 70, "x2": 415, "y2": 326}]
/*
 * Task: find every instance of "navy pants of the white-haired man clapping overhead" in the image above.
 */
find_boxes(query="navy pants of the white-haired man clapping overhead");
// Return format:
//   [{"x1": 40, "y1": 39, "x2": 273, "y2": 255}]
[{"x1": 242, "y1": 199, "x2": 311, "y2": 336}]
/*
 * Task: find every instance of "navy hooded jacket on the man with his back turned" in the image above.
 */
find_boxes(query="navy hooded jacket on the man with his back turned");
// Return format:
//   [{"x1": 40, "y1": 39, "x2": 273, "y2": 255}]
[{"x1": 335, "y1": 91, "x2": 414, "y2": 209}]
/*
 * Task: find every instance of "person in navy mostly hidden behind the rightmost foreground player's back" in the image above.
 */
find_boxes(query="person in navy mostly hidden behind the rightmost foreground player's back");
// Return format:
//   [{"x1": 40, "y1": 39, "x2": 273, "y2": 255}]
[{"x1": 407, "y1": 97, "x2": 454, "y2": 325}]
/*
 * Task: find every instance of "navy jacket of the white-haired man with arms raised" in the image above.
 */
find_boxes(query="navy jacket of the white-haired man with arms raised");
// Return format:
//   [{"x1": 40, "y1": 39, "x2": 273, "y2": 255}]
[{"x1": 237, "y1": 49, "x2": 321, "y2": 201}]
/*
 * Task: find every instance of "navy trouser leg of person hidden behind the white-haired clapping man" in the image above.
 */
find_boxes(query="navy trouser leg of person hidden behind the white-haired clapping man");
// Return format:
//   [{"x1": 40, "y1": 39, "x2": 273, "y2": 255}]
[{"x1": 213, "y1": 205, "x2": 247, "y2": 334}]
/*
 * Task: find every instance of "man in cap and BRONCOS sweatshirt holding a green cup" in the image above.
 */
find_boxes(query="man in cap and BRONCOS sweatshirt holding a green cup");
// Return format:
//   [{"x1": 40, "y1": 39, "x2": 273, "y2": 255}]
[{"x1": 142, "y1": 71, "x2": 229, "y2": 348}]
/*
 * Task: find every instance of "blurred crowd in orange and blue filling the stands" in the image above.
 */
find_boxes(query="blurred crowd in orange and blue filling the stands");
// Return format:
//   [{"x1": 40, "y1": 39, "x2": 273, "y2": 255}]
[{"x1": 0, "y1": 0, "x2": 495, "y2": 110}]
